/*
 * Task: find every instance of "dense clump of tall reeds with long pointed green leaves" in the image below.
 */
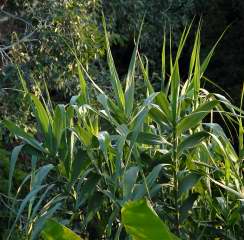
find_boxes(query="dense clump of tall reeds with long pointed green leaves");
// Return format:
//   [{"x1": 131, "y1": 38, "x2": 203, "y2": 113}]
[{"x1": 0, "y1": 17, "x2": 244, "y2": 239}]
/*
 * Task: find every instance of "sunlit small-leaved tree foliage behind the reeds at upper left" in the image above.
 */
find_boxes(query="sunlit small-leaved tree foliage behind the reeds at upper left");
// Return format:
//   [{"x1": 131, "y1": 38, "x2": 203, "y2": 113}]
[{"x1": 0, "y1": 0, "x2": 104, "y2": 122}]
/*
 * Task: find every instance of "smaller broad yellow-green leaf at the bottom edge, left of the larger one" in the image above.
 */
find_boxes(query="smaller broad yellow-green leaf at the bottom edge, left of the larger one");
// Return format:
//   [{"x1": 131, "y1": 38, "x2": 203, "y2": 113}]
[{"x1": 41, "y1": 219, "x2": 81, "y2": 240}]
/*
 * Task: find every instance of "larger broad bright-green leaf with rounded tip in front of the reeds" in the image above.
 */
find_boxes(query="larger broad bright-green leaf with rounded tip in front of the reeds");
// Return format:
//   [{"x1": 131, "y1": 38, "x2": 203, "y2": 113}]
[{"x1": 121, "y1": 200, "x2": 178, "y2": 240}]
